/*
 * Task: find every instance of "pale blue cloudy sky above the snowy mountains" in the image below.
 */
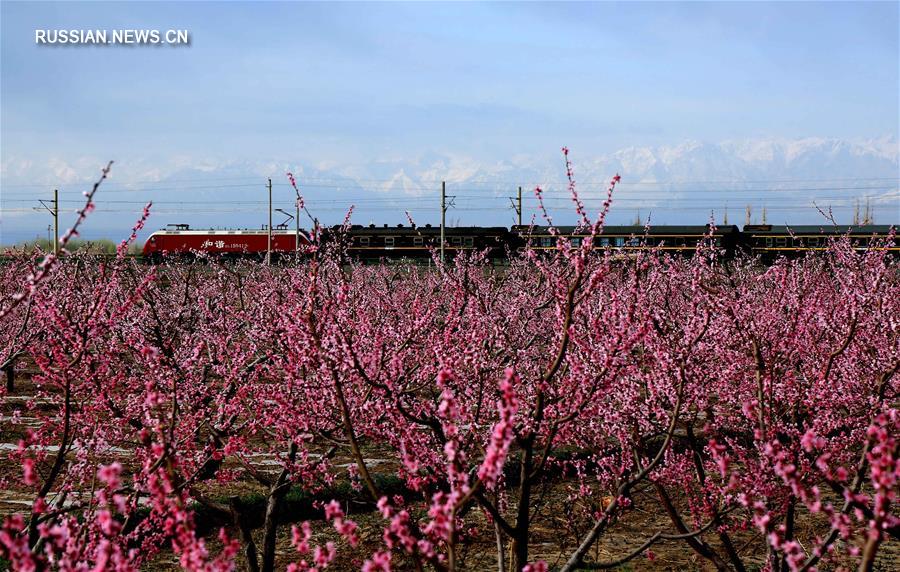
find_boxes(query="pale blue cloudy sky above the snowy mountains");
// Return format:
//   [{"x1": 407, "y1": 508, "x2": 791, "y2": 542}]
[{"x1": 0, "y1": 1, "x2": 900, "y2": 241}]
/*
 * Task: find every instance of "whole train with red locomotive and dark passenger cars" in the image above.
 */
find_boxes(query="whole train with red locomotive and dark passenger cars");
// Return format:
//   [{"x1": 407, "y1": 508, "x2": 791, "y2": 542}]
[{"x1": 143, "y1": 224, "x2": 900, "y2": 261}]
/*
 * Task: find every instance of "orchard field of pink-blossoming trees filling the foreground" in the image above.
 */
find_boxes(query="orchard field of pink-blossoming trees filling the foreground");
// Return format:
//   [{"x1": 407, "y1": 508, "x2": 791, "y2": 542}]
[{"x1": 0, "y1": 175, "x2": 900, "y2": 572}]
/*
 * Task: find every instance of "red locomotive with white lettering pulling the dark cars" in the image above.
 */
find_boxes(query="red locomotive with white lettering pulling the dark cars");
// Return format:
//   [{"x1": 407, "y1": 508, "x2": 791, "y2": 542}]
[{"x1": 144, "y1": 224, "x2": 310, "y2": 258}]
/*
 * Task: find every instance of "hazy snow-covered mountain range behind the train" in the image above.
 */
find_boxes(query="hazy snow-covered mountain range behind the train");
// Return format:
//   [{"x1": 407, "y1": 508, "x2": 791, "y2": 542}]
[{"x1": 0, "y1": 136, "x2": 900, "y2": 243}]
